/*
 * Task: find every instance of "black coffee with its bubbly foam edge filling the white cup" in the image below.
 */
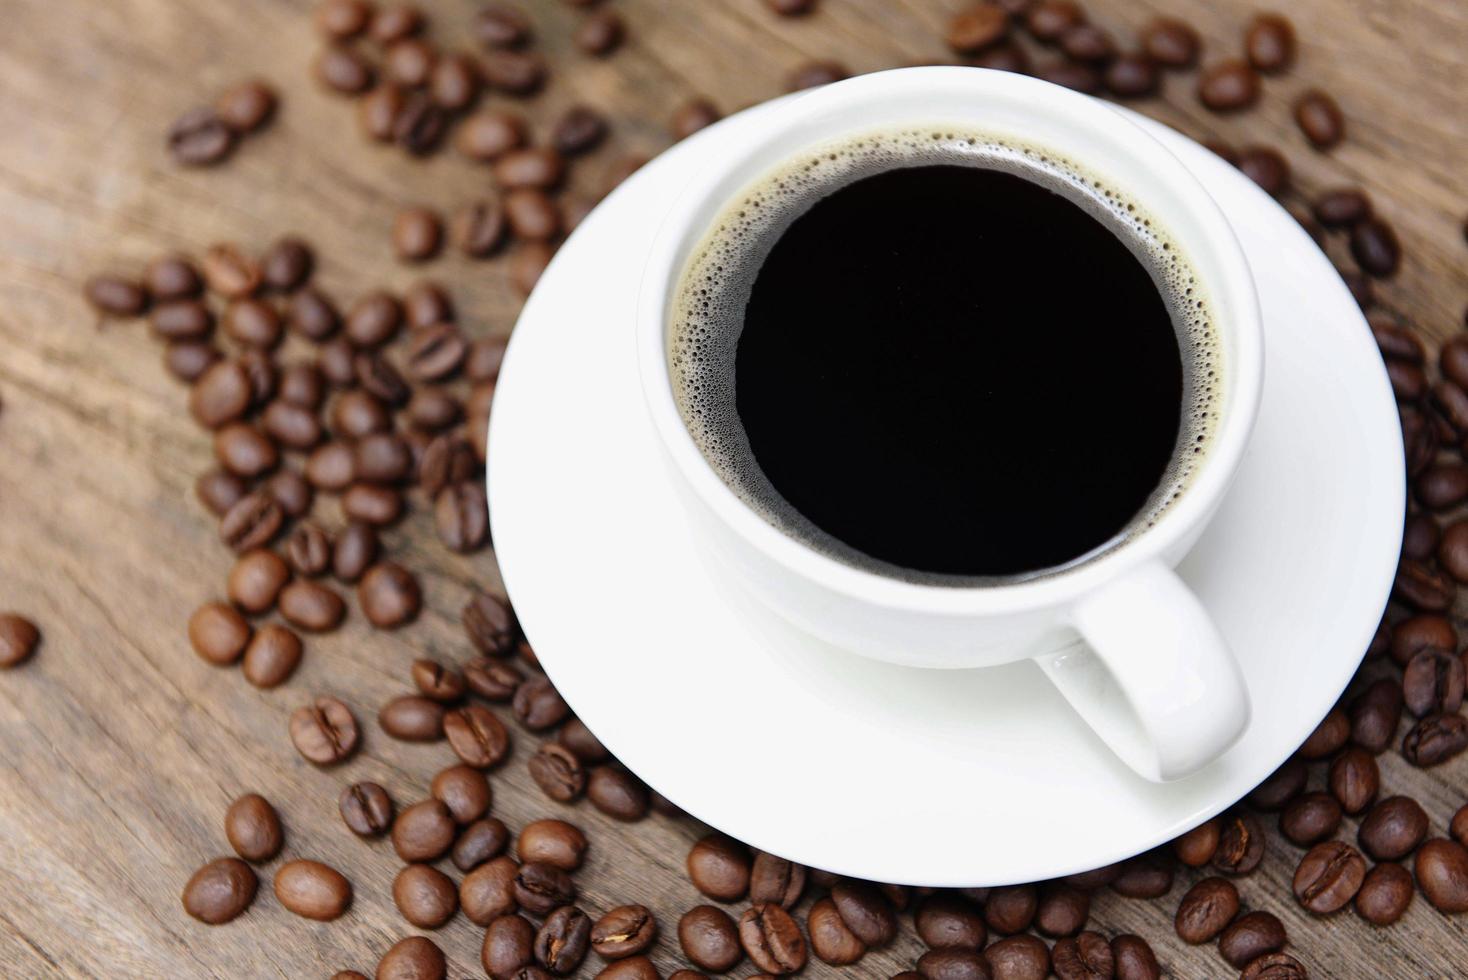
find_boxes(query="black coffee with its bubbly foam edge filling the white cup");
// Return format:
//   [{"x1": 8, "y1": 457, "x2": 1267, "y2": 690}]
[{"x1": 671, "y1": 131, "x2": 1216, "y2": 578}]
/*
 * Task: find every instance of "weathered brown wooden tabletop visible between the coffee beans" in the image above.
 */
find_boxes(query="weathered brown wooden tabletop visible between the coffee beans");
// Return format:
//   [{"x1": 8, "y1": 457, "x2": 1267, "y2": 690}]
[{"x1": 0, "y1": 0, "x2": 1468, "y2": 977}]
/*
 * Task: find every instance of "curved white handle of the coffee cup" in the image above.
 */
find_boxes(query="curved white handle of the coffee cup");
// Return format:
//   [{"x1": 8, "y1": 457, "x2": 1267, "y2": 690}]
[{"x1": 1036, "y1": 559, "x2": 1249, "y2": 782}]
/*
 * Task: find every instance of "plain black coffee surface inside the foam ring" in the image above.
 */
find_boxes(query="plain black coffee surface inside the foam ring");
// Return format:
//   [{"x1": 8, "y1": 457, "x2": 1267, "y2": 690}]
[{"x1": 734, "y1": 166, "x2": 1183, "y2": 577}]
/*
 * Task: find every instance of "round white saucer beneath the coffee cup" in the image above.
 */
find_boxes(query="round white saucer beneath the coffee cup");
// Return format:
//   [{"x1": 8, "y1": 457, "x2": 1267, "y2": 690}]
[{"x1": 489, "y1": 97, "x2": 1405, "y2": 886}]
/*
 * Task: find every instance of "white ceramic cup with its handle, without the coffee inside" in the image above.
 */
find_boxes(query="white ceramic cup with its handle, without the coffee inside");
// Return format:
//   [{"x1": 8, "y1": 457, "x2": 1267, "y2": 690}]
[{"x1": 637, "y1": 67, "x2": 1264, "y2": 780}]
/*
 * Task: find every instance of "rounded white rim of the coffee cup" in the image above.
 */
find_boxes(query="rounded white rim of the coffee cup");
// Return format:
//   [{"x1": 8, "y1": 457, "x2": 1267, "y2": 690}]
[{"x1": 637, "y1": 66, "x2": 1264, "y2": 615}]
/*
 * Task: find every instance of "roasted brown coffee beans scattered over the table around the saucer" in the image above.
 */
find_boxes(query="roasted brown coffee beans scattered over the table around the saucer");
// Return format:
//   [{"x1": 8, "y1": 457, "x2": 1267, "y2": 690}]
[{"x1": 57, "y1": 0, "x2": 1468, "y2": 980}]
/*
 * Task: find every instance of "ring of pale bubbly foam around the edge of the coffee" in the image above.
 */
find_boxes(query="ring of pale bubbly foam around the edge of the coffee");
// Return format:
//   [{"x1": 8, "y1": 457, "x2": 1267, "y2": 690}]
[{"x1": 666, "y1": 128, "x2": 1224, "y2": 585}]
